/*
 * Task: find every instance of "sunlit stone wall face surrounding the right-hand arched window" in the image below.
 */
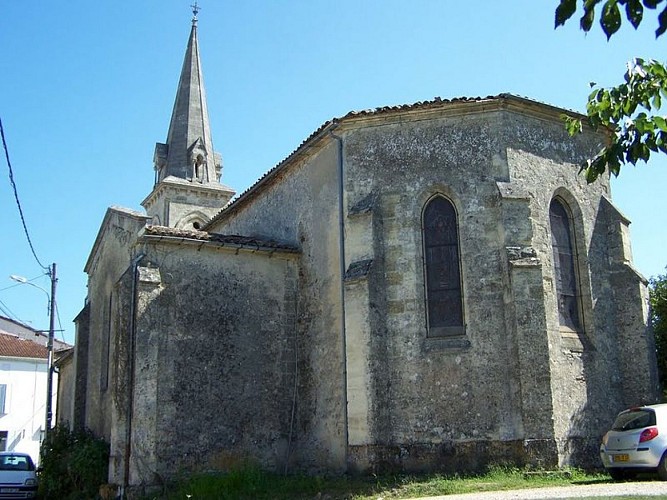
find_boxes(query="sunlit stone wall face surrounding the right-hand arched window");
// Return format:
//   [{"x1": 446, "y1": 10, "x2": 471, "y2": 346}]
[{"x1": 507, "y1": 117, "x2": 615, "y2": 466}]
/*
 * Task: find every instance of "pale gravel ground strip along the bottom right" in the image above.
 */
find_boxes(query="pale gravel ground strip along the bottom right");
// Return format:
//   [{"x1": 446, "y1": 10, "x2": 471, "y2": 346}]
[{"x1": 417, "y1": 481, "x2": 667, "y2": 500}]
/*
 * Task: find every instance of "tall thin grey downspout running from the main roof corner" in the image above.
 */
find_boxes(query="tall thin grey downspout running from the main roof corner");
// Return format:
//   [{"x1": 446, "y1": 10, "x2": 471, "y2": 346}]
[{"x1": 329, "y1": 122, "x2": 350, "y2": 470}]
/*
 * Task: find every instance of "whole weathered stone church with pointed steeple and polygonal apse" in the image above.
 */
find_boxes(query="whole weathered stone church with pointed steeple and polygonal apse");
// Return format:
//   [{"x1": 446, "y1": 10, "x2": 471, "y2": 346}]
[{"x1": 69, "y1": 9, "x2": 658, "y2": 487}]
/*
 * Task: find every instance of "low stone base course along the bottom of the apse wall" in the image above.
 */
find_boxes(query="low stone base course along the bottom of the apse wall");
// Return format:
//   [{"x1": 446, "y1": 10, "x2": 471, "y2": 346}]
[{"x1": 348, "y1": 439, "x2": 559, "y2": 474}]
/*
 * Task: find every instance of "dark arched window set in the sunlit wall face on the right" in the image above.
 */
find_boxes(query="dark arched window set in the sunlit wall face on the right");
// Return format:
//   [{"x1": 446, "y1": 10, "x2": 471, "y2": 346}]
[{"x1": 549, "y1": 198, "x2": 582, "y2": 332}]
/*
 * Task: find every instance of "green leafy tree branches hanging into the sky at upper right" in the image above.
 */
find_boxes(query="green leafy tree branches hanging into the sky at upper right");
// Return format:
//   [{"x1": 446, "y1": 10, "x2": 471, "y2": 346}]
[{"x1": 556, "y1": 0, "x2": 667, "y2": 182}]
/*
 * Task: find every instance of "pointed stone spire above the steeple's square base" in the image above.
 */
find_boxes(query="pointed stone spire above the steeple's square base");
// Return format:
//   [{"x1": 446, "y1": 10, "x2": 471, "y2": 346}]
[{"x1": 155, "y1": 5, "x2": 220, "y2": 184}]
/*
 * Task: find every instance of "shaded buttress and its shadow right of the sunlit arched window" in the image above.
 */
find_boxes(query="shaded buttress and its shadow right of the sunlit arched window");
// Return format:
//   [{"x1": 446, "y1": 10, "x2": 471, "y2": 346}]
[{"x1": 561, "y1": 197, "x2": 659, "y2": 469}]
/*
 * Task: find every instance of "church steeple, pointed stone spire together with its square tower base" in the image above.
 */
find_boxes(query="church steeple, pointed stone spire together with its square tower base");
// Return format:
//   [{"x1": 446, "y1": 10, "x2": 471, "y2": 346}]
[{"x1": 142, "y1": 3, "x2": 234, "y2": 227}]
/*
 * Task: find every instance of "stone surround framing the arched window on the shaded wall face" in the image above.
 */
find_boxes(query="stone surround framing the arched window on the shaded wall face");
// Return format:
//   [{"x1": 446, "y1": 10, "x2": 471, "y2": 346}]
[{"x1": 420, "y1": 191, "x2": 466, "y2": 339}]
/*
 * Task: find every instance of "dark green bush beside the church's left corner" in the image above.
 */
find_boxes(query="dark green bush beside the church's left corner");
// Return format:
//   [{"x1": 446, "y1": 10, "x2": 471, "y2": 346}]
[{"x1": 39, "y1": 426, "x2": 109, "y2": 500}]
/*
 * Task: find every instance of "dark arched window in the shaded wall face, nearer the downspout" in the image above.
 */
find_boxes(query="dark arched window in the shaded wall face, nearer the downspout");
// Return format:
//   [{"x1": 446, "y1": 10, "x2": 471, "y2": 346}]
[{"x1": 423, "y1": 196, "x2": 464, "y2": 337}]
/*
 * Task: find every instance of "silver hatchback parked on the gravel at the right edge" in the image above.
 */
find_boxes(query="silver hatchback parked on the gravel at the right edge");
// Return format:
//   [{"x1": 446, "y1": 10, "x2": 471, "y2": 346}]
[{"x1": 600, "y1": 404, "x2": 667, "y2": 481}]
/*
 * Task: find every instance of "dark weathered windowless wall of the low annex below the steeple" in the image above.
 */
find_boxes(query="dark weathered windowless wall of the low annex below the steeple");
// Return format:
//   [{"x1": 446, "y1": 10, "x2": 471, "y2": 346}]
[{"x1": 111, "y1": 243, "x2": 298, "y2": 484}]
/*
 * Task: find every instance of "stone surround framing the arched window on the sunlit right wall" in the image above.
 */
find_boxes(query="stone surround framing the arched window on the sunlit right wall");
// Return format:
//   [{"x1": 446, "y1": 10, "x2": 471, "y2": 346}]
[{"x1": 546, "y1": 188, "x2": 593, "y2": 350}]
